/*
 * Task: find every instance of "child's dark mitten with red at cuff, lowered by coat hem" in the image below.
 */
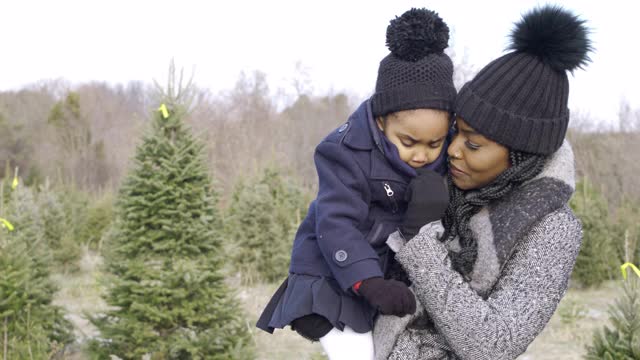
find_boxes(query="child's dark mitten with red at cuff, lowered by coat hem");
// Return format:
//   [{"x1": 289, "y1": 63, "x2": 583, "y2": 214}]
[{"x1": 358, "y1": 277, "x2": 416, "y2": 317}]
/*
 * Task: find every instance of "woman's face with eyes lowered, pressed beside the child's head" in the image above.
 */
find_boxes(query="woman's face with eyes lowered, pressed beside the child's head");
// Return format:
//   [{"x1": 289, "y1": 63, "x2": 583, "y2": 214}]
[{"x1": 447, "y1": 117, "x2": 510, "y2": 190}]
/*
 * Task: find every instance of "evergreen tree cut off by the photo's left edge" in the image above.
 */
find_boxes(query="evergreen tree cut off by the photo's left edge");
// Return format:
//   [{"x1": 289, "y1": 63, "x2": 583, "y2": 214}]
[{"x1": 0, "y1": 186, "x2": 73, "y2": 359}]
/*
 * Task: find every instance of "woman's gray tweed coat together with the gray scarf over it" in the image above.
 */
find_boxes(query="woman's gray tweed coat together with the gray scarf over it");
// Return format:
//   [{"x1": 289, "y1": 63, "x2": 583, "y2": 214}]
[{"x1": 374, "y1": 142, "x2": 582, "y2": 360}]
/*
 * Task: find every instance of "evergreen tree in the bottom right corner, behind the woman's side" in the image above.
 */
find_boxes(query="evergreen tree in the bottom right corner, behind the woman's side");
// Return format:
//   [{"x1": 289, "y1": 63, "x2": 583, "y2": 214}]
[{"x1": 586, "y1": 275, "x2": 640, "y2": 360}]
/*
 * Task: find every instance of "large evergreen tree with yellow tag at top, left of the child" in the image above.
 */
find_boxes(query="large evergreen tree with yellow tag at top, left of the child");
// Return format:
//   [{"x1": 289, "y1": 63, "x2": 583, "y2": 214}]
[{"x1": 91, "y1": 88, "x2": 252, "y2": 359}]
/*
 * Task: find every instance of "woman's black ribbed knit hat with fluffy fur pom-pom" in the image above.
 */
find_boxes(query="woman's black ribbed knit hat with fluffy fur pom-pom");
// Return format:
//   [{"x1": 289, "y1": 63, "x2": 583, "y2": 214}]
[{"x1": 454, "y1": 5, "x2": 592, "y2": 155}]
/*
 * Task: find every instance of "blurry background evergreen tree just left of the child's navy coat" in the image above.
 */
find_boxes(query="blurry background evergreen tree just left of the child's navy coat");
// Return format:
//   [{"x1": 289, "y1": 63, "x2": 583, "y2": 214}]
[{"x1": 225, "y1": 166, "x2": 308, "y2": 283}]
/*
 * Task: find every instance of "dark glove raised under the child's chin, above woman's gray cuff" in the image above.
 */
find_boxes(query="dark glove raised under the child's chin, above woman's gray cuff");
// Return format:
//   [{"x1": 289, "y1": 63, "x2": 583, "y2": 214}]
[{"x1": 400, "y1": 168, "x2": 449, "y2": 240}]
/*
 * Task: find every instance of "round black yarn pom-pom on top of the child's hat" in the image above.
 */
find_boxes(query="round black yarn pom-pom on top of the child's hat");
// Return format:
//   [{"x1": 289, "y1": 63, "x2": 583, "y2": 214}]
[{"x1": 387, "y1": 9, "x2": 449, "y2": 61}]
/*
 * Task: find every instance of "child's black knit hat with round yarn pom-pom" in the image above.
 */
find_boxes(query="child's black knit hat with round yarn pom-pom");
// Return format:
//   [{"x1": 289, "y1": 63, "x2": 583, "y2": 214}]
[{"x1": 371, "y1": 9, "x2": 456, "y2": 117}]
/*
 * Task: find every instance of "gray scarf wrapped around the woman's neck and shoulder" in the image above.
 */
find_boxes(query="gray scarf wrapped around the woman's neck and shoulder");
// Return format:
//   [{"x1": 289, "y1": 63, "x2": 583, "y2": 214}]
[{"x1": 442, "y1": 144, "x2": 574, "y2": 296}]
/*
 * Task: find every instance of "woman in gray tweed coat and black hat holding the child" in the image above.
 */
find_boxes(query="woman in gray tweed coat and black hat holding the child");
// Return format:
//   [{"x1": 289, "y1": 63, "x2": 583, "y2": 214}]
[{"x1": 374, "y1": 6, "x2": 591, "y2": 360}]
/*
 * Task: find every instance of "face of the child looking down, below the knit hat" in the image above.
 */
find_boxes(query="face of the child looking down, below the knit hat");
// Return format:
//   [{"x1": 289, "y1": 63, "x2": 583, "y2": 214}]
[{"x1": 376, "y1": 109, "x2": 449, "y2": 169}]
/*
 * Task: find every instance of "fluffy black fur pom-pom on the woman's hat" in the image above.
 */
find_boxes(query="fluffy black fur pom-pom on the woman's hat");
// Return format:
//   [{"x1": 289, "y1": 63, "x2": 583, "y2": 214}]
[{"x1": 509, "y1": 5, "x2": 593, "y2": 71}]
